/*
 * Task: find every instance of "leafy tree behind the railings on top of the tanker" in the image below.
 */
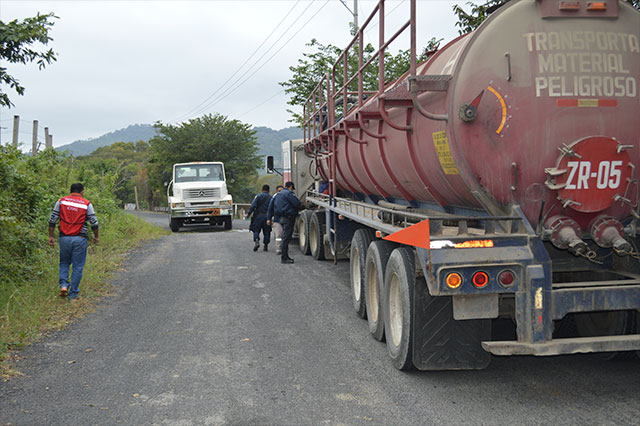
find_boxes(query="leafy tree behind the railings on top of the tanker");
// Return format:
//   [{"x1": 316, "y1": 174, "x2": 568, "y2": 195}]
[{"x1": 279, "y1": 37, "x2": 442, "y2": 124}]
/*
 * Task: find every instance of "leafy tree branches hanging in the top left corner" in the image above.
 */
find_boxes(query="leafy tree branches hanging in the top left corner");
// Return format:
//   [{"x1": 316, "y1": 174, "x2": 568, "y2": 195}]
[{"x1": 0, "y1": 13, "x2": 57, "y2": 108}]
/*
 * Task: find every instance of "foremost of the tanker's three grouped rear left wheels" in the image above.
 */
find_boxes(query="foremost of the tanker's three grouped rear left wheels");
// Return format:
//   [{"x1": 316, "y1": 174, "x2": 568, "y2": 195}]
[{"x1": 349, "y1": 228, "x2": 375, "y2": 318}]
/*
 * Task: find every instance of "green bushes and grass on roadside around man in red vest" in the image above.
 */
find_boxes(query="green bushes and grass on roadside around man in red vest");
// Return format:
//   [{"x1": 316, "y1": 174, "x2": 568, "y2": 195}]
[{"x1": 0, "y1": 146, "x2": 163, "y2": 370}]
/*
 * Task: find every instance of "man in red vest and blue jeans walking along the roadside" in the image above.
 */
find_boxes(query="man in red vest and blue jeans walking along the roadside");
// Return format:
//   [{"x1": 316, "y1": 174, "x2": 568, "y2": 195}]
[{"x1": 49, "y1": 183, "x2": 98, "y2": 300}]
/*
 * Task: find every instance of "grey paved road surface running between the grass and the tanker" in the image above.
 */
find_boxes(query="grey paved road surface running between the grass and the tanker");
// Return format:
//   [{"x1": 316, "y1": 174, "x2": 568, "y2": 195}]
[{"x1": 0, "y1": 211, "x2": 640, "y2": 426}]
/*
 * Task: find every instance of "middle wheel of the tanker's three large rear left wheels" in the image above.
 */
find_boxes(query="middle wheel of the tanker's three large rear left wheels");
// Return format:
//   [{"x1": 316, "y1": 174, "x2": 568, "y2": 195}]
[{"x1": 364, "y1": 240, "x2": 396, "y2": 342}]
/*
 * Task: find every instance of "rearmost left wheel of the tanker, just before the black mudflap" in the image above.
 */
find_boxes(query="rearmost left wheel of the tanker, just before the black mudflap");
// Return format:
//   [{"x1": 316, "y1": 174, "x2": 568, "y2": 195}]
[{"x1": 383, "y1": 247, "x2": 415, "y2": 370}]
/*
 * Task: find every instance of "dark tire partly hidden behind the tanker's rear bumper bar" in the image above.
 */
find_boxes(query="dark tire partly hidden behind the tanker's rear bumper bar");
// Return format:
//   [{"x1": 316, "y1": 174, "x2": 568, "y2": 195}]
[{"x1": 573, "y1": 311, "x2": 636, "y2": 361}]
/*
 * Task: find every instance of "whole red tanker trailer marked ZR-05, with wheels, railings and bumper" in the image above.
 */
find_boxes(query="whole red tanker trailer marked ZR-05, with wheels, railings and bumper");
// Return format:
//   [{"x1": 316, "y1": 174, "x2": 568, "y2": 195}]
[{"x1": 268, "y1": 0, "x2": 640, "y2": 370}]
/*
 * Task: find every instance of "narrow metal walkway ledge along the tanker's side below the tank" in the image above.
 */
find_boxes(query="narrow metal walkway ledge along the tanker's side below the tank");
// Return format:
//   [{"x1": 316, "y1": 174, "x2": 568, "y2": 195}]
[{"x1": 306, "y1": 191, "x2": 532, "y2": 239}]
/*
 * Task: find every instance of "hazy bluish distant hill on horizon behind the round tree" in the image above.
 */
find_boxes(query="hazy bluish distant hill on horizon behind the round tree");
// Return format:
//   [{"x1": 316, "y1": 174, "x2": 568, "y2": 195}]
[{"x1": 56, "y1": 124, "x2": 302, "y2": 164}]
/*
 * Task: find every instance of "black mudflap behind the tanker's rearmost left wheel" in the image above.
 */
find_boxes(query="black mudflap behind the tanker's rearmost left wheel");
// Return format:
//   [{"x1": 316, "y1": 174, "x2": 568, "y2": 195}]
[{"x1": 413, "y1": 272, "x2": 491, "y2": 370}]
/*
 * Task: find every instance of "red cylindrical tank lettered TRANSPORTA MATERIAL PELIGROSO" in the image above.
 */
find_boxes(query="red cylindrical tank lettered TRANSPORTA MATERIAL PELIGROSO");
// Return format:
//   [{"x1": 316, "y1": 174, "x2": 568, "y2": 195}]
[{"x1": 318, "y1": 0, "x2": 640, "y2": 229}]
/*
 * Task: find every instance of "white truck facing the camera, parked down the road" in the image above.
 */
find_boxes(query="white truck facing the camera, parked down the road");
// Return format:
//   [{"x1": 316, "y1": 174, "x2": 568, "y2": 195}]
[{"x1": 167, "y1": 162, "x2": 233, "y2": 232}]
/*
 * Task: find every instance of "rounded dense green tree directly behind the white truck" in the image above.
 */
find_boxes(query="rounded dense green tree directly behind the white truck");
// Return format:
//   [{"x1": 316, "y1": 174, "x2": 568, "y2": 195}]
[{"x1": 149, "y1": 114, "x2": 260, "y2": 201}]
